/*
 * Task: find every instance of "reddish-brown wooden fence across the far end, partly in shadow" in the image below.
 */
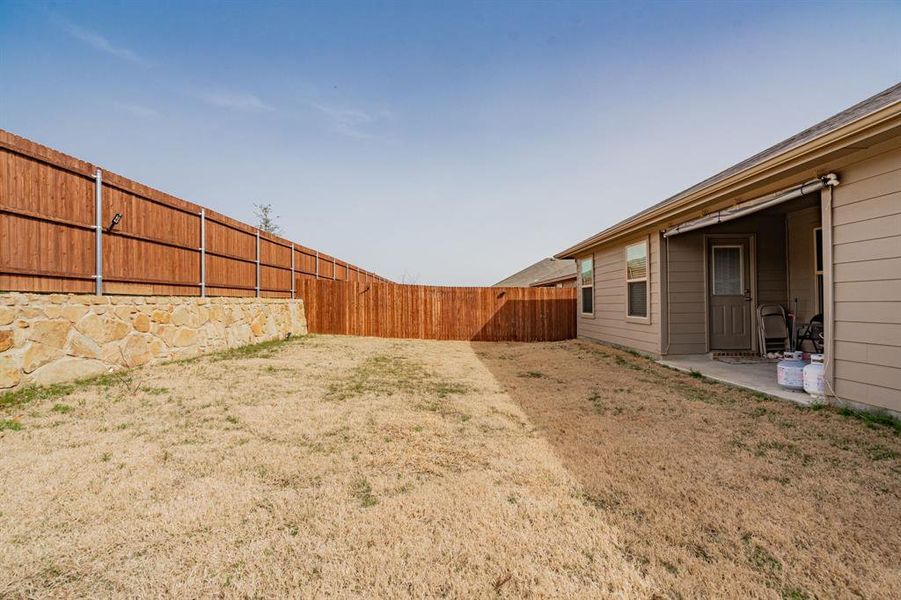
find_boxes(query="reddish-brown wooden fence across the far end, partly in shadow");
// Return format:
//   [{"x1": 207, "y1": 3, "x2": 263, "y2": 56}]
[{"x1": 297, "y1": 280, "x2": 576, "y2": 342}]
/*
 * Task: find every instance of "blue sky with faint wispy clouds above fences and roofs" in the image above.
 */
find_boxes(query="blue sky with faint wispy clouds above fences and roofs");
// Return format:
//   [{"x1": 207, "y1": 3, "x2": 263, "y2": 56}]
[{"x1": 0, "y1": 0, "x2": 901, "y2": 285}]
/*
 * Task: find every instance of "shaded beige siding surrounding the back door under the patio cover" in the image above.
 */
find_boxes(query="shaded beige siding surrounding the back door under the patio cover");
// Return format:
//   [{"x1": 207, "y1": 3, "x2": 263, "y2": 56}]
[{"x1": 664, "y1": 214, "x2": 787, "y2": 354}]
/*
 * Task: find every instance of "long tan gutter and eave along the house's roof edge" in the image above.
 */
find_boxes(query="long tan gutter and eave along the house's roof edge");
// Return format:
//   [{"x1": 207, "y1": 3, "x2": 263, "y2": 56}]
[{"x1": 554, "y1": 101, "x2": 901, "y2": 259}]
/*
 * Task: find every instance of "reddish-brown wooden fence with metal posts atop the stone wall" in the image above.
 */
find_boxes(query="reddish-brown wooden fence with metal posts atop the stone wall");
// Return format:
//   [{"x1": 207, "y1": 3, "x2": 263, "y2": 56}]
[{"x1": 0, "y1": 130, "x2": 386, "y2": 298}]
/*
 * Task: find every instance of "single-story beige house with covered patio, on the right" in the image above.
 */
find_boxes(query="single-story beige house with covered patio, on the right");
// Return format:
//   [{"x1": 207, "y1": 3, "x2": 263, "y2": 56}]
[{"x1": 556, "y1": 84, "x2": 901, "y2": 413}]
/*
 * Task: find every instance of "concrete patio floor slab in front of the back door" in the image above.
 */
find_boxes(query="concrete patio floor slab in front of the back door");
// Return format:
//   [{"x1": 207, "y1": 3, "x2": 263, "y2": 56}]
[{"x1": 658, "y1": 354, "x2": 812, "y2": 404}]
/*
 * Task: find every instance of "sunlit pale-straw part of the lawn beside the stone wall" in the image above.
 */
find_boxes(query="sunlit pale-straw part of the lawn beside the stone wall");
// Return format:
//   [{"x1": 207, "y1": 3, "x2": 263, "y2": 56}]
[{"x1": 0, "y1": 336, "x2": 652, "y2": 598}]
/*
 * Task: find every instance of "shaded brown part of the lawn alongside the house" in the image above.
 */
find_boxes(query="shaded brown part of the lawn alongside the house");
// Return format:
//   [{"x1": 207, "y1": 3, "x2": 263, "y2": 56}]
[{"x1": 473, "y1": 341, "x2": 901, "y2": 598}]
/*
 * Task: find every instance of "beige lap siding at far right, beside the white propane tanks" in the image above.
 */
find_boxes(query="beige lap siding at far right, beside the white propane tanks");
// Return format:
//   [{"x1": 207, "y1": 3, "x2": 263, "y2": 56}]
[{"x1": 832, "y1": 148, "x2": 901, "y2": 411}]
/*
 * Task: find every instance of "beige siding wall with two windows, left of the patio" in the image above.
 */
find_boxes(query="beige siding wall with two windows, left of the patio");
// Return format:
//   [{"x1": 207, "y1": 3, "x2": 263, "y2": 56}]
[{"x1": 578, "y1": 233, "x2": 660, "y2": 354}]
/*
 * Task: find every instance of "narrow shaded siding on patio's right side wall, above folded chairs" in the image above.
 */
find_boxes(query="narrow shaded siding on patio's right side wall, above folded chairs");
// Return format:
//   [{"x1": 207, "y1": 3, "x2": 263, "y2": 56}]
[{"x1": 786, "y1": 206, "x2": 822, "y2": 323}]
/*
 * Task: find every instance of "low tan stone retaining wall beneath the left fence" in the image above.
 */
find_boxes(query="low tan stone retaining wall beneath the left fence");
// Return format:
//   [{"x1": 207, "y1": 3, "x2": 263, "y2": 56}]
[{"x1": 0, "y1": 293, "x2": 307, "y2": 389}]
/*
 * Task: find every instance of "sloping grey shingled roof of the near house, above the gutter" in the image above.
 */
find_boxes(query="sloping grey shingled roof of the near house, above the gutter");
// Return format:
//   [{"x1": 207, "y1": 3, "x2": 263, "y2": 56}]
[{"x1": 555, "y1": 83, "x2": 901, "y2": 258}]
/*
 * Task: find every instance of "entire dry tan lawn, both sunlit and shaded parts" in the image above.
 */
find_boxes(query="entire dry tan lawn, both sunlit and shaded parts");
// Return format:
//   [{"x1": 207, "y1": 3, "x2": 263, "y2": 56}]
[{"x1": 0, "y1": 336, "x2": 901, "y2": 598}]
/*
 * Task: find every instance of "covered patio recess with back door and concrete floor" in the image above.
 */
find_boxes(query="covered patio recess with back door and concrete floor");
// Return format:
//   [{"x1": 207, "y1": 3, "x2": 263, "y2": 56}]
[{"x1": 660, "y1": 182, "x2": 827, "y2": 404}]
